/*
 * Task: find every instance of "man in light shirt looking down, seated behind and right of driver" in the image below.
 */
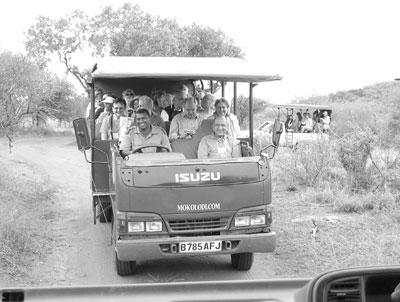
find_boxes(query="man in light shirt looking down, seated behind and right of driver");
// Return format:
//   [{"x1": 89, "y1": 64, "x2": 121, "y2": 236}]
[{"x1": 169, "y1": 97, "x2": 203, "y2": 140}]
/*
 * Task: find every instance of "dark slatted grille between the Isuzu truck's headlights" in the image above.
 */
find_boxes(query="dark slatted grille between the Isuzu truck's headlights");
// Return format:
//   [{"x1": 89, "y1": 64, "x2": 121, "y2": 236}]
[{"x1": 168, "y1": 217, "x2": 229, "y2": 232}]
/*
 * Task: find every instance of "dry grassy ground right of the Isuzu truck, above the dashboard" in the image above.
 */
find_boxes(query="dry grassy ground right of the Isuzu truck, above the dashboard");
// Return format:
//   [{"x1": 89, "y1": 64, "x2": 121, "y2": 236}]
[{"x1": 273, "y1": 191, "x2": 400, "y2": 277}]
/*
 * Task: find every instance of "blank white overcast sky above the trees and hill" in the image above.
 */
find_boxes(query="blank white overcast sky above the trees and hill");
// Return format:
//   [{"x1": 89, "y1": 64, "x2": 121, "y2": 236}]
[{"x1": 0, "y1": 0, "x2": 400, "y2": 102}]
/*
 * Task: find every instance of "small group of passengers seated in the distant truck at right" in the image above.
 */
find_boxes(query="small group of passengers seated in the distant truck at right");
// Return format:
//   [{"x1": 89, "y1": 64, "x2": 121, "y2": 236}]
[{"x1": 285, "y1": 110, "x2": 331, "y2": 133}]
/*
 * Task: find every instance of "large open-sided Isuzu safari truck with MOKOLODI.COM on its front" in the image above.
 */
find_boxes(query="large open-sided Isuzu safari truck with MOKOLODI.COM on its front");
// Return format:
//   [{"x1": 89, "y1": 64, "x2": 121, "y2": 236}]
[{"x1": 73, "y1": 57, "x2": 281, "y2": 276}]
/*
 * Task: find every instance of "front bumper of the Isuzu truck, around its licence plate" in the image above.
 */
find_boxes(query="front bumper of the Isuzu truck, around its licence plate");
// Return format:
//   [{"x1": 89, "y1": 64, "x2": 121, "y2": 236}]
[{"x1": 115, "y1": 232, "x2": 276, "y2": 261}]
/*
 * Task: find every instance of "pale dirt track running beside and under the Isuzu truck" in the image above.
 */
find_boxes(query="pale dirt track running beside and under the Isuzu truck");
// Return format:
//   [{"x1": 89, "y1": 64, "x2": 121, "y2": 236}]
[{"x1": 7, "y1": 136, "x2": 276, "y2": 286}]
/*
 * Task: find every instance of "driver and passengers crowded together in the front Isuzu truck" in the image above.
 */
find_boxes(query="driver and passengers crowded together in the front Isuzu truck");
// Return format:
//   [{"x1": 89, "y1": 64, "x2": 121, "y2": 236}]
[{"x1": 87, "y1": 85, "x2": 241, "y2": 158}]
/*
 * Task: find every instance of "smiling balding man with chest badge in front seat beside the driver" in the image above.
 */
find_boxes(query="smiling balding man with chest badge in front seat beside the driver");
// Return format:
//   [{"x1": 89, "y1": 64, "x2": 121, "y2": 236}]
[{"x1": 197, "y1": 115, "x2": 242, "y2": 159}]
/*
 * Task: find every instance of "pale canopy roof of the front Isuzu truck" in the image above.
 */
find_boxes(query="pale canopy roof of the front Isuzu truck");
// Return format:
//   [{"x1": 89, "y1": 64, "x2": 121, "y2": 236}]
[{"x1": 92, "y1": 57, "x2": 282, "y2": 83}]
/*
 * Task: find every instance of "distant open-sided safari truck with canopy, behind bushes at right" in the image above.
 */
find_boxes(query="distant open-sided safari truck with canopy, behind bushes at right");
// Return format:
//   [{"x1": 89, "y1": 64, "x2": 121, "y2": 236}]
[{"x1": 255, "y1": 104, "x2": 332, "y2": 147}]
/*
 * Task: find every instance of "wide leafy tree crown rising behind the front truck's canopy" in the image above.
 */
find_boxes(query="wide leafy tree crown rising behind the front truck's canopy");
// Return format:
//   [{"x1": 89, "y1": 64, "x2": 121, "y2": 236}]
[{"x1": 26, "y1": 3, "x2": 243, "y2": 91}]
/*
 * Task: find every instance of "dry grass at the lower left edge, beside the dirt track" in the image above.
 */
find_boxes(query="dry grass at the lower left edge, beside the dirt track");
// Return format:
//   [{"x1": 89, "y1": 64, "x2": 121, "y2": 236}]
[{"x1": 0, "y1": 157, "x2": 55, "y2": 285}]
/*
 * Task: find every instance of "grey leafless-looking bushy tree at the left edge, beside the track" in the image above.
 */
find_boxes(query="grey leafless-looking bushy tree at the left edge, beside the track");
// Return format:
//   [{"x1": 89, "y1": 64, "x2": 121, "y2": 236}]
[{"x1": 0, "y1": 52, "x2": 83, "y2": 151}]
